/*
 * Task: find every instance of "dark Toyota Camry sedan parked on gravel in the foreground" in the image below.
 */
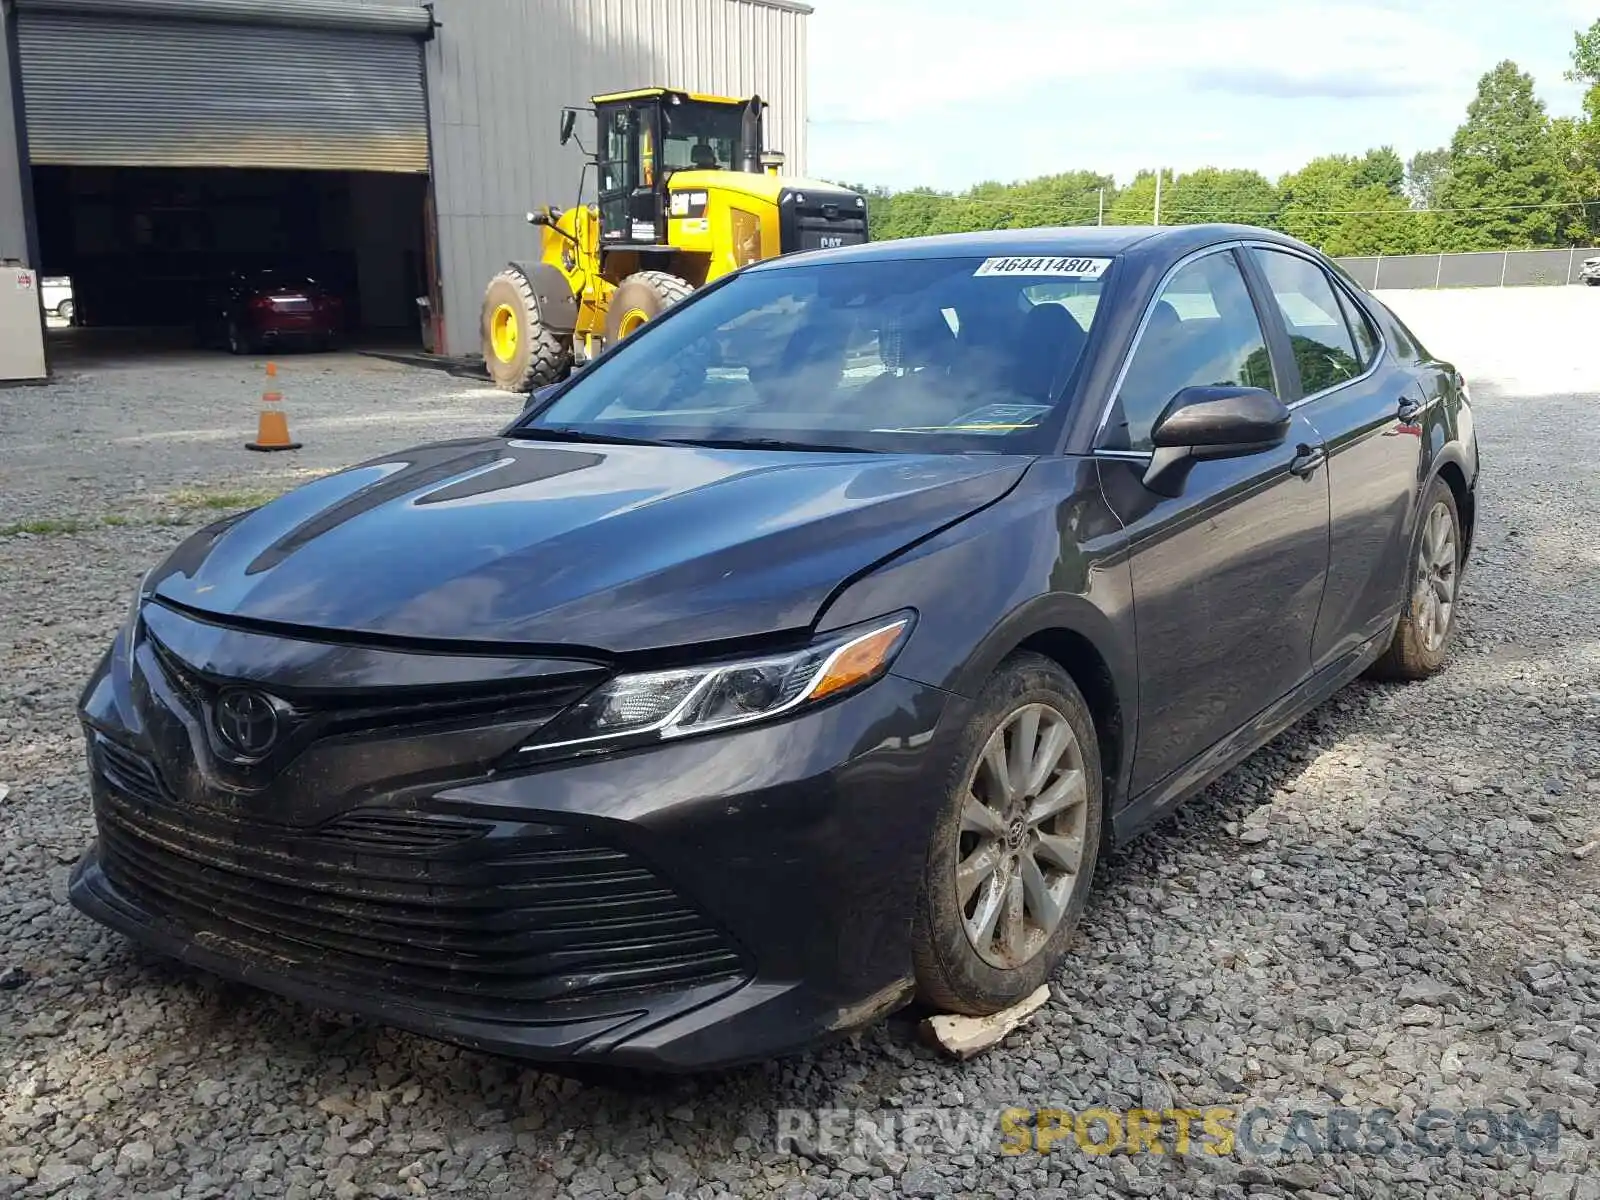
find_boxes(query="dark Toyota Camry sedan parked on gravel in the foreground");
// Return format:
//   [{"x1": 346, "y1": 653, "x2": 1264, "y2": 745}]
[{"x1": 72, "y1": 226, "x2": 1478, "y2": 1070}]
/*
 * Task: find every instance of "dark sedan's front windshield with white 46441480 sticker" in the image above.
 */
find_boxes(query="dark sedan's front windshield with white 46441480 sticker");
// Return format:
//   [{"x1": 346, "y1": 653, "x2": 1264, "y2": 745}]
[{"x1": 520, "y1": 258, "x2": 1109, "y2": 453}]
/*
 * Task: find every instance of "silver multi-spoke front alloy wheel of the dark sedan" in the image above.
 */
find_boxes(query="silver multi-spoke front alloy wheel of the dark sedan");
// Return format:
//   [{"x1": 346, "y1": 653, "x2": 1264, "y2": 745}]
[{"x1": 955, "y1": 704, "x2": 1088, "y2": 970}]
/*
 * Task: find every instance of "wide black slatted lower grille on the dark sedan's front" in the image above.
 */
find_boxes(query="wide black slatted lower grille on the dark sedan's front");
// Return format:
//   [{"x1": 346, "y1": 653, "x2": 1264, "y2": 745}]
[{"x1": 94, "y1": 736, "x2": 747, "y2": 1019}]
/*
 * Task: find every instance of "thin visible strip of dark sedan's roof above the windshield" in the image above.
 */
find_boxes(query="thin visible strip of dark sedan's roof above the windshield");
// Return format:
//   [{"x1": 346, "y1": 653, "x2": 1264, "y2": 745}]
[{"x1": 754, "y1": 224, "x2": 1309, "y2": 270}]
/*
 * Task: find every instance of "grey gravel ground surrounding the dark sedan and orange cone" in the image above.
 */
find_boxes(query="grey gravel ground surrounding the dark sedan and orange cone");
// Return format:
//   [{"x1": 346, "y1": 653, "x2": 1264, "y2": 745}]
[{"x1": 0, "y1": 302, "x2": 1600, "y2": 1200}]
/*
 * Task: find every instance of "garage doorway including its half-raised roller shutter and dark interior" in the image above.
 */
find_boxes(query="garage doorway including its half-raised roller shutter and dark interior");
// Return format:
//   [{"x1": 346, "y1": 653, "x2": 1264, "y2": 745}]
[{"x1": 13, "y1": 0, "x2": 437, "y2": 366}]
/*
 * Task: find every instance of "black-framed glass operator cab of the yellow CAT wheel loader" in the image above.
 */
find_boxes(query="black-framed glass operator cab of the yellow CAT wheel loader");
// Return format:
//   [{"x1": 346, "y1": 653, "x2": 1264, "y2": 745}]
[{"x1": 588, "y1": 88, "x2": 765, "y2": 251}]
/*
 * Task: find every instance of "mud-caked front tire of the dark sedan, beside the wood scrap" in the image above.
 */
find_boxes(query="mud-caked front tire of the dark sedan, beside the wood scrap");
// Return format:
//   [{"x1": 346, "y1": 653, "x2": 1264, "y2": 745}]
[{"x1": 912, "y1": 653, "x2": 1102, "y2": 1016}]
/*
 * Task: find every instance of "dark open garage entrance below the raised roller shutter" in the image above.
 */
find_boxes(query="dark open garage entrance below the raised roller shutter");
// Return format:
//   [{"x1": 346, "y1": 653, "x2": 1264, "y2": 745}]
[{"x1": 34, "y1": 165, "x2": 429, "y2": 349}]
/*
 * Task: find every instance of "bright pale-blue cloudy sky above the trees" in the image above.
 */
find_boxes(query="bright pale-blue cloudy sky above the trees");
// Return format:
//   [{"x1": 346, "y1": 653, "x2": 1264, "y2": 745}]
[{"x1": 806, "y1": 0, "x2": 1600, "y2": 189}]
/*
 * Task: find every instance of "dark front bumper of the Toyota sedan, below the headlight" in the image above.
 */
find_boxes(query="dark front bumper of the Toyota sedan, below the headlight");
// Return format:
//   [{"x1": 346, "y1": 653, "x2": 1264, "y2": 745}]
[{"x1": 70, "y1": 643, "x2": 962, "y2": 1070}]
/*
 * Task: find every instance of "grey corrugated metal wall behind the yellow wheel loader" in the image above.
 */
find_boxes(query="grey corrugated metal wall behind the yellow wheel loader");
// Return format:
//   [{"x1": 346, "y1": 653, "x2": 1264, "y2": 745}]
[{"x1": 427, "y1": 0, "x2": 808, "y2": 354}]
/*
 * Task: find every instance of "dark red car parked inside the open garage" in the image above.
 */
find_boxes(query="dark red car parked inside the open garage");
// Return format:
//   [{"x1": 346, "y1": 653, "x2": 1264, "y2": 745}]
[{"x1": 202, "y1": 270, "x2": 344, "y2": 354}]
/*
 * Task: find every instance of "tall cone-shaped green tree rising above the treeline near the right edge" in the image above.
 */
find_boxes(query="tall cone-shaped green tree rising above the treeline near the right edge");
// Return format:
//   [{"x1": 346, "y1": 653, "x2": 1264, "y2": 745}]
[{"x1": 1438, "y1": 61, "x2": 1571, "y2": 250}]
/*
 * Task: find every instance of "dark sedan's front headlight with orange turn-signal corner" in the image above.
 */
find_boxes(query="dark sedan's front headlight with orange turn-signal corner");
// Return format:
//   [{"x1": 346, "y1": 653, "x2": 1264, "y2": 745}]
[{"x1": 523, "y1": 613, "x2": 912, "y2": 752}]
